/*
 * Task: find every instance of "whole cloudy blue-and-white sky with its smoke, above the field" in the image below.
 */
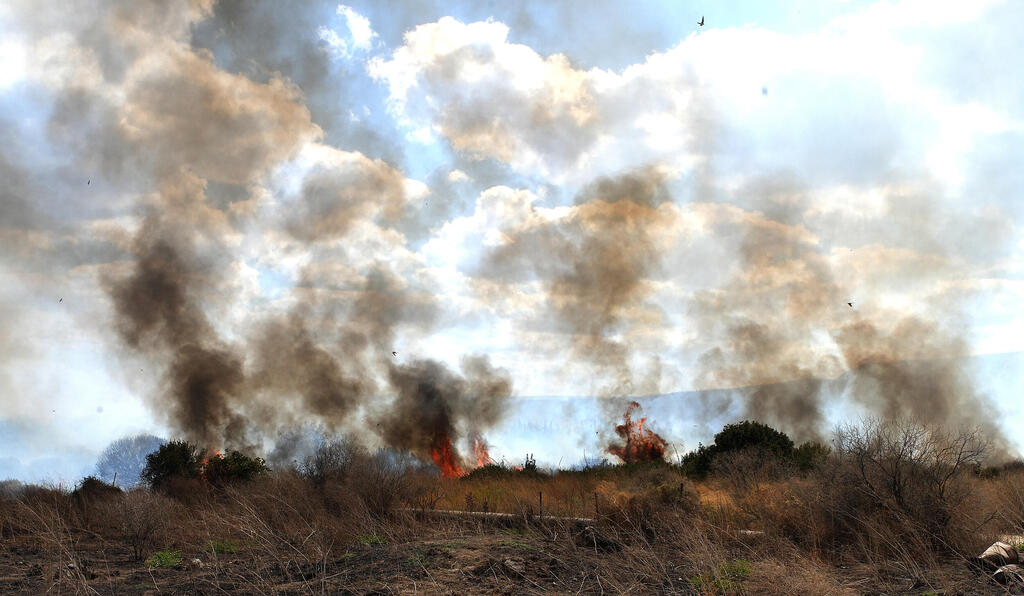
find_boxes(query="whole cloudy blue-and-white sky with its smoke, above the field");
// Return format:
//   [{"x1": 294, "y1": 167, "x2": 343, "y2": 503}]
[{"x1": 0, "y1": 0, "x2": 1024, "y2": 481}]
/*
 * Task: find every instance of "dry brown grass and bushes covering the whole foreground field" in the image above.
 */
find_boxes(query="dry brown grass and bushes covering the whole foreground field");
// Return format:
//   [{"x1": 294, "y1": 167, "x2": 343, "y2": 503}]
[{"x1": 0, "y1": 421, "x2": 1024, "y2": 594}]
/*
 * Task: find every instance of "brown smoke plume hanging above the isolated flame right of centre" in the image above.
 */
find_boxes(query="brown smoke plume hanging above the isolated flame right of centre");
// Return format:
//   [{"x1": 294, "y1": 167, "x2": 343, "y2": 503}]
[{"x1": 480, "y1": 167, "x2": 677, "y2": 396}]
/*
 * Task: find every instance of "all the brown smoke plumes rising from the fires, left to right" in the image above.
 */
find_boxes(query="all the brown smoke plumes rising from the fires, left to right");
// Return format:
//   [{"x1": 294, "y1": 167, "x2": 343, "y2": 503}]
[{"x1": 6, "y1": 1, "x2": 1005, "y2": 475}]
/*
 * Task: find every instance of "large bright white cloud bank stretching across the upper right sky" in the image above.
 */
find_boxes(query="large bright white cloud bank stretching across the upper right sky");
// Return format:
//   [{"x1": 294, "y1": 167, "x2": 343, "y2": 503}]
[{"x1": 368, "y1": 8, "x2": 1020, "y2": 190}]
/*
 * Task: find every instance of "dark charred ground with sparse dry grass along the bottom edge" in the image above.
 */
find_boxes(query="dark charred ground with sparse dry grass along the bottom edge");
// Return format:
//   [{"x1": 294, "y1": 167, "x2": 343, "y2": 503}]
[{"x1": 0, "y1": 525, "x2": 1019, "y2": 596}]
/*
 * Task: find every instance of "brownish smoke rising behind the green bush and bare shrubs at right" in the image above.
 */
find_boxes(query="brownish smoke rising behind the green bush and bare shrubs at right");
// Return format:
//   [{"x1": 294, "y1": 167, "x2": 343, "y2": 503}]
[{"x1": 689, "y1": 183, "x2": 1008, "y2": 454}]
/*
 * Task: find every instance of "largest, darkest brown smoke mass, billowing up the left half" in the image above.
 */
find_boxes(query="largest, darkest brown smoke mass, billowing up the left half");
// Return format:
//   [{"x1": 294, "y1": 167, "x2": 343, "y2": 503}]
[{"x1": 62, "y1": 3, "x2": 511, "y2": 462}]
